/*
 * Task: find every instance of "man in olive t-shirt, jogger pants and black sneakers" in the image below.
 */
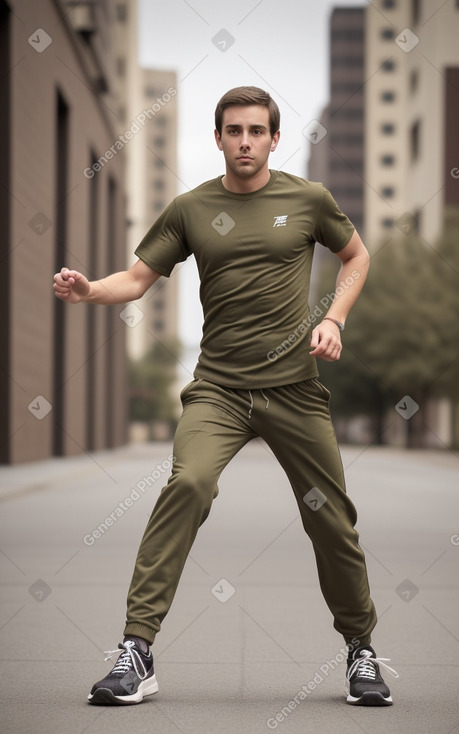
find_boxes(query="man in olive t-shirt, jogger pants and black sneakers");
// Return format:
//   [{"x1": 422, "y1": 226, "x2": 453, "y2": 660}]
[{"x1": 54, "y1": 87, "x2": 398, "y2": 706}]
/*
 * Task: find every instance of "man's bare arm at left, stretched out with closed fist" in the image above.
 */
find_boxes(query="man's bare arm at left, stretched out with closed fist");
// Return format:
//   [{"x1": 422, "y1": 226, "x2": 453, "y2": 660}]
[{"x1": 53, "y1": 260, "x2": 161, "y2": 306}]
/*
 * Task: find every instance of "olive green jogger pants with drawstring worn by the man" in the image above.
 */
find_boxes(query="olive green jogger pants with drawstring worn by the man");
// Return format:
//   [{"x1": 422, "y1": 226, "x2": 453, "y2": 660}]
[{"x1": 124, "y1": 378, "x2": 376, "y2": 645}]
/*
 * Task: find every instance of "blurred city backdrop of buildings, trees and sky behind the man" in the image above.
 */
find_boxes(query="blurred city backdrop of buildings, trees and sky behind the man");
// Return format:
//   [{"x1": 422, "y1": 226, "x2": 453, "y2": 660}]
[{"x1": 0, "y1": 0, "x2": 459, "y2": 464}]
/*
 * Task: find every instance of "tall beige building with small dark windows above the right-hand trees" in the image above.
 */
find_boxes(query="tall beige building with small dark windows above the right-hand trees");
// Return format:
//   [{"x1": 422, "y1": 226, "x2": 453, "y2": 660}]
[{"x1": 364, "y1": 0, "x2": 459, "y2": 247}]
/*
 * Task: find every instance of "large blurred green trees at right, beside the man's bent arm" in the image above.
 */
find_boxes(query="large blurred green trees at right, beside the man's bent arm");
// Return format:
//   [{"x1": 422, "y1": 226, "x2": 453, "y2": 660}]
[{"x1": 319, "y1": 212, "x2": 459, "y2": 448}]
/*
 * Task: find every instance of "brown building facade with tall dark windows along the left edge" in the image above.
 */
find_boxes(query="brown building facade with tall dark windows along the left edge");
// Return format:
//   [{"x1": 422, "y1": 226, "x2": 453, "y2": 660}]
[{"x1": 0, "y1": 0, "x2": 127, "y2": 463}]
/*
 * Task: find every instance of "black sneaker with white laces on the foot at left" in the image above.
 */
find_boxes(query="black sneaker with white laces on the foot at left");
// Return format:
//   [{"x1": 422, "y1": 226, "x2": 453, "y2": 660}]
[{"x1": 88, "y1": 640, "x2": 158, "y2": 706}]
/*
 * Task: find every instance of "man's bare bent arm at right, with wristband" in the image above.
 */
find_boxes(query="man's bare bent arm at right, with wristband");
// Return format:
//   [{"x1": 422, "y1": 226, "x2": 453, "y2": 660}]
[{"x1": 310, "y1": 230, "x2": 370, "y2": 362}]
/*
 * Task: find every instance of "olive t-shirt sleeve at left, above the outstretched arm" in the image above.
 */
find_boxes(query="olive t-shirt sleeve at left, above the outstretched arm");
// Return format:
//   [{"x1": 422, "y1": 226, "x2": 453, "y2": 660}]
[{"x1": 135, "y1": 199, "x2": 190, "y2": 278}]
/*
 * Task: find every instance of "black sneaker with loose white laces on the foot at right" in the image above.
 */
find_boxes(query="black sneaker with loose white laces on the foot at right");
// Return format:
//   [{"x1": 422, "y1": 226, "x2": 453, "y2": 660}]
[{"x1": 346, "y1": 645, "x2": 398, "y2": 706}]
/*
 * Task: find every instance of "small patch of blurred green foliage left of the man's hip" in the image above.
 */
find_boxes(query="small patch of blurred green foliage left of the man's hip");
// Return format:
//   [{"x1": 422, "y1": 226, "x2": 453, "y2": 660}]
[{"x1": 129, "y1": 341, "x2": 180, "y2": 423}]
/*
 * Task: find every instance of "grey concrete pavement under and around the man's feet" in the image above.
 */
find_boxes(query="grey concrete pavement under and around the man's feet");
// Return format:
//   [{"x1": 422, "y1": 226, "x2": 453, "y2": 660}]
[{"x1": 0, "y1": 442, "x2": 459, "y2": 734}]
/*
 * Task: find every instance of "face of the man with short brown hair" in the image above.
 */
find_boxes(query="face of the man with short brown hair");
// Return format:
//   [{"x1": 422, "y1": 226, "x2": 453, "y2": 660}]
[{"x1": 215, "y1": 105, "x2": 279, "y2": 179}]
